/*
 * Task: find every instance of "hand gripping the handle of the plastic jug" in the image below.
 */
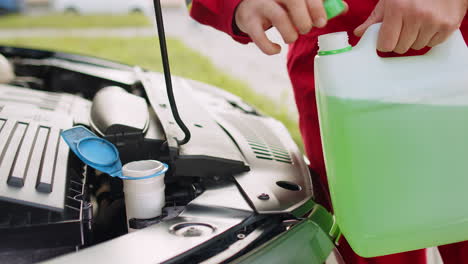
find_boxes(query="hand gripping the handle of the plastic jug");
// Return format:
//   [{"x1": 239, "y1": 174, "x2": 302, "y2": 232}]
[{"x1": 354, "y1": 0, "x2": 468, "y2": 54}]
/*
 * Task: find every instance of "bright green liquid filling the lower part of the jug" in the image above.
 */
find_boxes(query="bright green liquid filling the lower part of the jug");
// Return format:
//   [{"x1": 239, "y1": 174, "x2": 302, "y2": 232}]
[{"x1": 318, "y1": 94, "x2": 468, "y2": 257}]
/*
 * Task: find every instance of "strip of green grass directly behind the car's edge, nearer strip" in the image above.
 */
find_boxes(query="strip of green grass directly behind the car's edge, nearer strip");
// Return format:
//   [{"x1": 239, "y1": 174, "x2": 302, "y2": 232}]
[{"x1": 0, "y1": 37, "x2": 302, "y2": 146}]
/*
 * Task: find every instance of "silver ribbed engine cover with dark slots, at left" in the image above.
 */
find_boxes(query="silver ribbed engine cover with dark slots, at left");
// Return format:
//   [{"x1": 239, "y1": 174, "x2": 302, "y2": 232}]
[{"x1": 0, "y1": 87, "x2": 86, "y2": 212}]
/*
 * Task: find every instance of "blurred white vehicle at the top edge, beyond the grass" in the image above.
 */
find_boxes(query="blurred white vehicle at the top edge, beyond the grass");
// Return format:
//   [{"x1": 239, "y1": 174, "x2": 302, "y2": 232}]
[{"x1": 53, "y1": 0, "x2": 153, "y2": 14}]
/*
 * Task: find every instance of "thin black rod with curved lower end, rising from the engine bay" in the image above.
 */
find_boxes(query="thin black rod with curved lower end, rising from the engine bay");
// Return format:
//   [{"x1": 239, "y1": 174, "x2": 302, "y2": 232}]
[{"x1": 153, "y1": 0, "x2": 191, "y2": 146}]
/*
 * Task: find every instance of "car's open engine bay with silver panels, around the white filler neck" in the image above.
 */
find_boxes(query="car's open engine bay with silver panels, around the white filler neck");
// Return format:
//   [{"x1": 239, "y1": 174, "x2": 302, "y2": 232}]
[{"x1": 0, "y1": 46, "x2": 313, "y2": 263}]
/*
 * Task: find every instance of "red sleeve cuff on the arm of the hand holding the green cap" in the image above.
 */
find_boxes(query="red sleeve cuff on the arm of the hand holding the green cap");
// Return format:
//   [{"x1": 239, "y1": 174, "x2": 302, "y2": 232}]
[{"x1": 188, "y1": 0, "x2": 252, "y2": 44}]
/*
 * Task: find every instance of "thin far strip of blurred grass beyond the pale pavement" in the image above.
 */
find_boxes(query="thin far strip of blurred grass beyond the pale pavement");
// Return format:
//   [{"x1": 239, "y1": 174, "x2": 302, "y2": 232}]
[{"x1": 0, "y1": 14, "x2": 151, "y2": 29}]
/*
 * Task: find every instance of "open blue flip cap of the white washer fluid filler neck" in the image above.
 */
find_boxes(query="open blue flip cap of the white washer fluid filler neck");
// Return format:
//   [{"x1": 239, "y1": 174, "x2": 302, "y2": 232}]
[{"x1": 61, "y1": 126, "x2": 123, "y2": 178}]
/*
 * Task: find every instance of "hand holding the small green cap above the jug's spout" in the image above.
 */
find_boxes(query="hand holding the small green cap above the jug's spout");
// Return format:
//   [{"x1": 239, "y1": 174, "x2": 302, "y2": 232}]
[{"x1": 235, "y1": 0, "x2": 348, "y2": 55}]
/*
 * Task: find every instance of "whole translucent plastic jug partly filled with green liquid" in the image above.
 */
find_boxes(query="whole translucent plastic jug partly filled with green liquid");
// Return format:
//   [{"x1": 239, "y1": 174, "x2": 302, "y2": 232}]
[{"x1": 315, "y1": 25, "x2": 468, "y2": 257}]
